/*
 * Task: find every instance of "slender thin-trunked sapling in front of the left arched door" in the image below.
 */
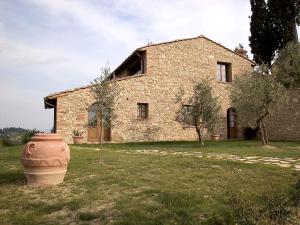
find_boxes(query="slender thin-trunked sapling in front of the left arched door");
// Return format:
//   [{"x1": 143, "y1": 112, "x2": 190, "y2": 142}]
[{"x1": 90, "y1": 66, "x2": 119, "y2": 163}]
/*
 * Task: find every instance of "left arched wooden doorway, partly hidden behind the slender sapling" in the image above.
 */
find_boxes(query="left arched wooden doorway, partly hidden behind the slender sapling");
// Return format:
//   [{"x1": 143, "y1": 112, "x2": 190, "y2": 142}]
[{"x1": 87, "y1": 104, "x2": 111, "y2": 143}]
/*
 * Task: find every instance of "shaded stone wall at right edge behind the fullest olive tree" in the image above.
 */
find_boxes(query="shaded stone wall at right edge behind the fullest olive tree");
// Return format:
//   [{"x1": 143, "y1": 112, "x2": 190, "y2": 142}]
[{"x1": 268, "y1": 89, "x2": 300, "y2": 141}]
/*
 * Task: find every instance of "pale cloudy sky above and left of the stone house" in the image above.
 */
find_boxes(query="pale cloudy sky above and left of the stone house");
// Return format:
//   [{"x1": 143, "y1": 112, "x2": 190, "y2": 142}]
[{"x1": 0, "y1": 0, "x2": 299, "y2": 131}]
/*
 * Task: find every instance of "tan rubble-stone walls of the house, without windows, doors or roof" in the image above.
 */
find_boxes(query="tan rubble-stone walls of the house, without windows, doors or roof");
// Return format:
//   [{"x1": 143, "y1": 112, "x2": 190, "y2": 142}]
[{"x1": 53, "y1": 38, "x2": 251, "y2": 142}]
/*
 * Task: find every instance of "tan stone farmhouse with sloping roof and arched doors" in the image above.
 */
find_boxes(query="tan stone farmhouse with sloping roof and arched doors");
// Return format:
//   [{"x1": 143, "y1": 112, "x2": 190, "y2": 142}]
[{"x1": 44, "y1": 36, "x2": 255, "y2": 143}]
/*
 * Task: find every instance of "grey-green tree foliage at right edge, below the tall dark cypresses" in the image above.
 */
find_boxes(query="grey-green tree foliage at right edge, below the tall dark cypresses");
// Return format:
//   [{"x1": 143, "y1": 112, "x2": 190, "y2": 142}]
[{"x1": 272, "y1": 42, "x2": 300, "y2": 88}]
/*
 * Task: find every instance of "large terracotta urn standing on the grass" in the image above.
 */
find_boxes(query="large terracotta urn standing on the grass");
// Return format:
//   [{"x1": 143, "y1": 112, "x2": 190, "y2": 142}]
[{"x1": 21, "y1": 133, "x2": 70, "y2": 185}]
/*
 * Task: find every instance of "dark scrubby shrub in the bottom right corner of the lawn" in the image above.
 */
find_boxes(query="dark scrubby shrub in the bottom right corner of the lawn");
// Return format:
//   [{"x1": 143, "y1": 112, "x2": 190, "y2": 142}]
[{"x1": 202, "y1": 185, "x2": 300, "y2": 225}]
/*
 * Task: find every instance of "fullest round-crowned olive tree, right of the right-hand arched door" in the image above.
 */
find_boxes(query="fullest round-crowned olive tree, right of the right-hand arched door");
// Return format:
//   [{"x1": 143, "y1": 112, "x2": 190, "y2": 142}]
[{"x1": 230, "y1": 66, "x2": 287, "y2": 145}]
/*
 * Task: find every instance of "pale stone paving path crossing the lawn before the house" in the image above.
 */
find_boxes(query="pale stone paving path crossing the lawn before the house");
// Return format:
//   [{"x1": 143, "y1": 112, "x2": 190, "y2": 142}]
[{"x1": 73, "y1": 147, "x2": 300, "y2": 171}]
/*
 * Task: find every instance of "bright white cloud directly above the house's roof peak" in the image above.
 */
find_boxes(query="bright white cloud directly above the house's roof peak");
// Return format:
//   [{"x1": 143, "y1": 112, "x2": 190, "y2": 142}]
[{"x1": 112, "y1": 0, "x2": 250, "y2": 48}]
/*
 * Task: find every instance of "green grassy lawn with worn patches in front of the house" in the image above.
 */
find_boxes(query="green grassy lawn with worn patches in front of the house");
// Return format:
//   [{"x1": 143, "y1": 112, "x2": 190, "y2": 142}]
[{"x1": 0, "y1": 141, "x2": 300, "y2": 225}]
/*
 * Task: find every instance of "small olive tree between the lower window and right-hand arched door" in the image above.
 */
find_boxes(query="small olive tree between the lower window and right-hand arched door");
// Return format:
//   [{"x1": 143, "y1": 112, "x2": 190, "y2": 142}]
[{"x1": 176, "y1": 79, "x2": 220, "y2": 145}]
